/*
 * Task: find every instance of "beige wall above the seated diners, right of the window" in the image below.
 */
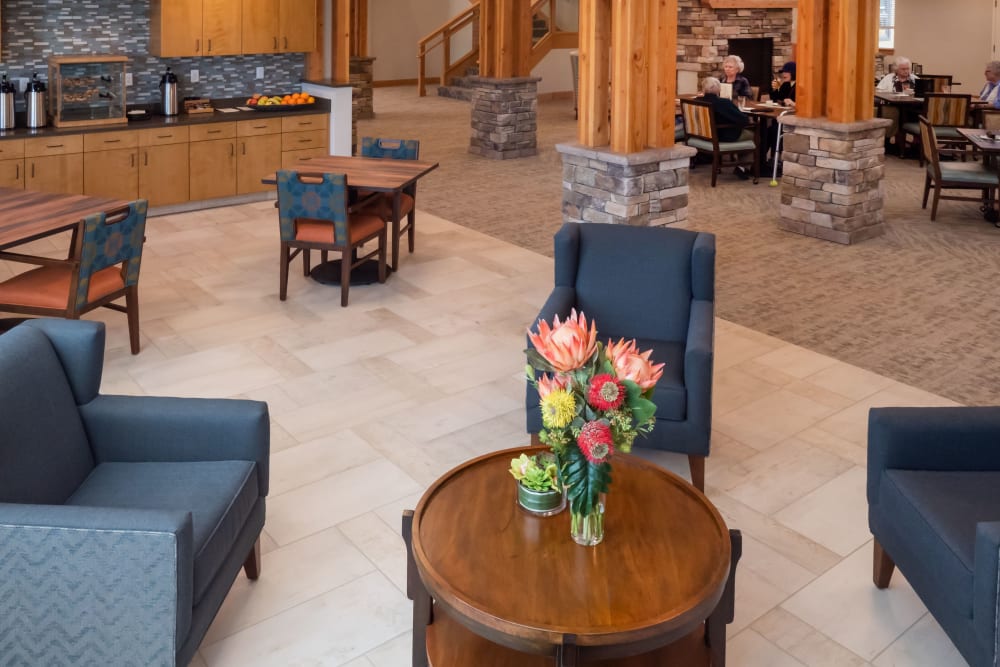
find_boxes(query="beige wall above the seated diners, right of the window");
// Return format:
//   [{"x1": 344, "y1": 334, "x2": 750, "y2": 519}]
[{"x1": 896, "y1": 0, "x2": 993, "y2": 94}]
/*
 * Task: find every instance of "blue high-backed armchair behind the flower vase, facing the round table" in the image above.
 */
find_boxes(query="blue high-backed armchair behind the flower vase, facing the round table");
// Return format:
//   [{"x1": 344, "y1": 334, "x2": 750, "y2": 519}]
[{"x1": 525, "y1": 223, "x2": 715, "y2": 489}]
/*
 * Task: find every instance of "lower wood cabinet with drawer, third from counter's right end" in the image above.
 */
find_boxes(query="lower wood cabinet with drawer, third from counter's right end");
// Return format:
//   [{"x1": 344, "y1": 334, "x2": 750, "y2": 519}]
[{"x1": 189, "y1": 123, "x2": 236, "y2": 200}]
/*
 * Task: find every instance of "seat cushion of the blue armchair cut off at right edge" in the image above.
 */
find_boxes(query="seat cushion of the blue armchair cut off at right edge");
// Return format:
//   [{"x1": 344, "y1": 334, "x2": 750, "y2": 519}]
[{"x1": 878, "y1": 469, "x2": 1000, "y2": 618}]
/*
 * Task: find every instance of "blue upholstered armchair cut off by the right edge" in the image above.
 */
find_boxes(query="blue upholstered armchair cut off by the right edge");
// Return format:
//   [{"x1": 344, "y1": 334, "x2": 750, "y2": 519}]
[{"x1": 868, "y1": 407, "x2": 1000, "y2": 667}]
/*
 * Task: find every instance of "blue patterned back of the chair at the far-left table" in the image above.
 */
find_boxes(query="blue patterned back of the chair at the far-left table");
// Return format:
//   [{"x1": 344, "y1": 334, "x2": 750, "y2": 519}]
[{"x1": 75, "y1": 199, "x2": 148, "y2": 309}]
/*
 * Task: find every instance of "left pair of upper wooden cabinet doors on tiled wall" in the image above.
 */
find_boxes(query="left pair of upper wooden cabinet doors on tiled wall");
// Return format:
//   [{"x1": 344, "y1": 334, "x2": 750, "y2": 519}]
[{"x1": 149, "y1": 0, "x2": 243, "y2": 57}]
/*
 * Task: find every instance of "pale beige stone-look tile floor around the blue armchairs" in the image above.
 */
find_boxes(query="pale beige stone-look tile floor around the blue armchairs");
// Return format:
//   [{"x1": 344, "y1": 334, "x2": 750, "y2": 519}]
[{"x1": 0, "y1": 202, "x2": 964, "y2": 667}]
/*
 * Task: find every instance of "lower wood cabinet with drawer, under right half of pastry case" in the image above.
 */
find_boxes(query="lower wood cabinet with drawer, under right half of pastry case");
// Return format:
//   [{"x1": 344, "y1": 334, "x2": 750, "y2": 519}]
[{"x1": 83, "y1": 130, "x2": 139, "y2": 201}]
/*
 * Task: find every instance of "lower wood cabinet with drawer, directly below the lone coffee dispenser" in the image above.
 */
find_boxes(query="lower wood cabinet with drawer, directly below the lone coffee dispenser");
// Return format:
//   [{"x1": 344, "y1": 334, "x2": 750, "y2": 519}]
[{"x1": 139, "y1": 127, "x2": 191, "y2": 206}]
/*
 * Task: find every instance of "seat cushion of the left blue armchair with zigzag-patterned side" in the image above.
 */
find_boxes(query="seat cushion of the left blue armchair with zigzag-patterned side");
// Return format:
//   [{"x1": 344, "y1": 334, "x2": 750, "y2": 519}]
[{"x1": 66, "y1": 461, "x2": 260, "y2": 605}]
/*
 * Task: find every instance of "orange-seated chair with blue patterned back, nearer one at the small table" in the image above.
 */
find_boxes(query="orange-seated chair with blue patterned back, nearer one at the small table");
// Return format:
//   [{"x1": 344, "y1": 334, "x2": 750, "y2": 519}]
[{"x1": 277, "y1": 170, "x2": 386, "y2": 306}]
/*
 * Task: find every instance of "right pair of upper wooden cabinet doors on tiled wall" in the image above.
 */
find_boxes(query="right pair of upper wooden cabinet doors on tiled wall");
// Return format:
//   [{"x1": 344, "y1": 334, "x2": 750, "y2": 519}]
[{"x1": 243, "y1": 0, "x2": 316, "y2": 53}]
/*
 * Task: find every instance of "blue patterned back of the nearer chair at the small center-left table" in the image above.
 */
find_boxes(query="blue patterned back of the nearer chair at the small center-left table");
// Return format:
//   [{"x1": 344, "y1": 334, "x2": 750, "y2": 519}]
[{"x1": 277, "y1": 169, "x2": 350, "y2": 245}]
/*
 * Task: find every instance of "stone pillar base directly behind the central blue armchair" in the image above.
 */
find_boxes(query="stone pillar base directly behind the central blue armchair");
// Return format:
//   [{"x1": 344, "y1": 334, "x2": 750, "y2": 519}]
[{"x1": 556, "y1": 143, "x2": 696, "y2": 226}]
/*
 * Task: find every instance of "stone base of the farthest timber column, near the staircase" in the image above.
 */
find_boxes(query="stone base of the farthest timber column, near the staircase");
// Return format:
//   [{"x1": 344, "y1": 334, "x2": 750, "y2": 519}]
[{"x1": 469, "y1": 76, "x2": 541, "y2": 160}]
